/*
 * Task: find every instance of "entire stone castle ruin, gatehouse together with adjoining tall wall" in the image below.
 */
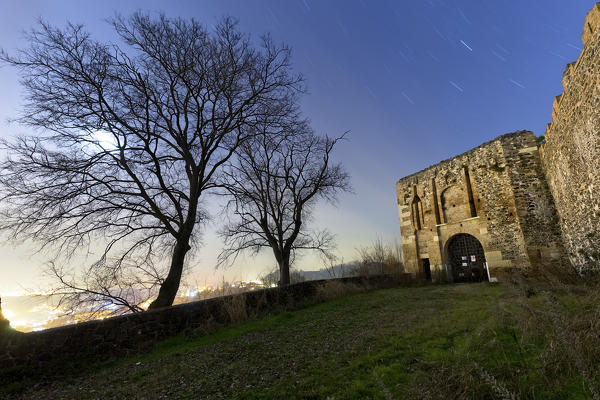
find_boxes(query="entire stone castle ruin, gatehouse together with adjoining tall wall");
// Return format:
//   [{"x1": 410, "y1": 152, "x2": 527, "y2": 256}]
[{"x1": 396, "y1": 3, "x2": 600, "y2": 280}]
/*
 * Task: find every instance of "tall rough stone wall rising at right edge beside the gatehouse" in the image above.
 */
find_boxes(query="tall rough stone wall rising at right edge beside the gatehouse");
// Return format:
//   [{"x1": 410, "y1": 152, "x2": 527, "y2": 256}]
[{"x1": 540, "y1": 3, "x2": 600, "y2": 272}]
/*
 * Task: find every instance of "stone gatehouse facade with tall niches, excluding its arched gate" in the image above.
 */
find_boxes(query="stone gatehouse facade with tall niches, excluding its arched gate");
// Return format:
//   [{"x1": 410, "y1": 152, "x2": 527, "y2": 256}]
[{"x1": 396, "y1": 131, "x2": 564, "y2": 278}]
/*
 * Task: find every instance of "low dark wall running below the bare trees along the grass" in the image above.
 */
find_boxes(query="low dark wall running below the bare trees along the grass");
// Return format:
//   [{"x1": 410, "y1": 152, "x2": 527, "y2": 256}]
[{"x1": 0, "y1": 274, "x2": 416, "y2": 384}]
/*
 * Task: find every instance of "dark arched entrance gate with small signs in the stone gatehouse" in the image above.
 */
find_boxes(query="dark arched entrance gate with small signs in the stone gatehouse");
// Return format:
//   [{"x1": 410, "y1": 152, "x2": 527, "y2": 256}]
[{"x1": 447, "y1": 233, "x2": 488, "y2": 282}]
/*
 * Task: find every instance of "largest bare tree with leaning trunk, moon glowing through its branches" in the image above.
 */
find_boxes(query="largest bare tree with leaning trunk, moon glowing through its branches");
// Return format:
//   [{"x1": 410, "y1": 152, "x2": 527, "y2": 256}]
[{"x1": 0, "y1": 13, "x2": 302, "y2": 308}]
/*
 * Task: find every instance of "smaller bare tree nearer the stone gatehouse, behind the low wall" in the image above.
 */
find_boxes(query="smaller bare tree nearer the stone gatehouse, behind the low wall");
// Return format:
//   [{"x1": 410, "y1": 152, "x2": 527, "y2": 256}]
[{"x1": 219, "y1": 116, "x2": 350, "y2": 285}]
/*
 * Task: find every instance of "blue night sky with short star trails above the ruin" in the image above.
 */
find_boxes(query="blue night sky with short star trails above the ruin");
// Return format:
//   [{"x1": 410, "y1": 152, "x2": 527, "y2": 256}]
[{"x1": 0, "y1": 0, "x2": 594, "y2": 293}]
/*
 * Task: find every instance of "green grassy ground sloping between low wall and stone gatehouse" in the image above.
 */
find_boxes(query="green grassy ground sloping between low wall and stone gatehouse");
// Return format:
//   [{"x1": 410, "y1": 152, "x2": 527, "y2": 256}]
[{"x1": 0, "y1": 283, "x2": 600, "y2": 400}]
